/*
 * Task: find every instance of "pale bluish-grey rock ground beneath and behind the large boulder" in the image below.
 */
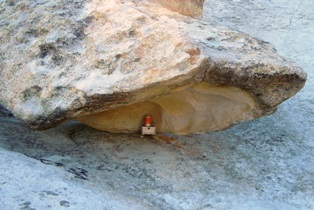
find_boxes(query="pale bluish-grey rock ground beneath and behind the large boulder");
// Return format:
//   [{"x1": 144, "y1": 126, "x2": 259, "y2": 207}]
[{"x1": 0, "y1": 0, "x2": 314, "y2": 209}]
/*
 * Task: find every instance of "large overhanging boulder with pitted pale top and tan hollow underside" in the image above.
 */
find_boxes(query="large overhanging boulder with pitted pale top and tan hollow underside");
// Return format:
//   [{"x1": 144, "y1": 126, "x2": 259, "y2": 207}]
[{"x1": 0, "y1": 0, "x2": 306, "y2": 134}]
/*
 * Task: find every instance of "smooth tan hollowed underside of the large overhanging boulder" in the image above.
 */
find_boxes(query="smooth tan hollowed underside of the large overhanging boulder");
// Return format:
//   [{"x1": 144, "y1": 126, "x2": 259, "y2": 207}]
[{"x1": 78, "y1": 82, "x2": 256, "y2": 135}]
